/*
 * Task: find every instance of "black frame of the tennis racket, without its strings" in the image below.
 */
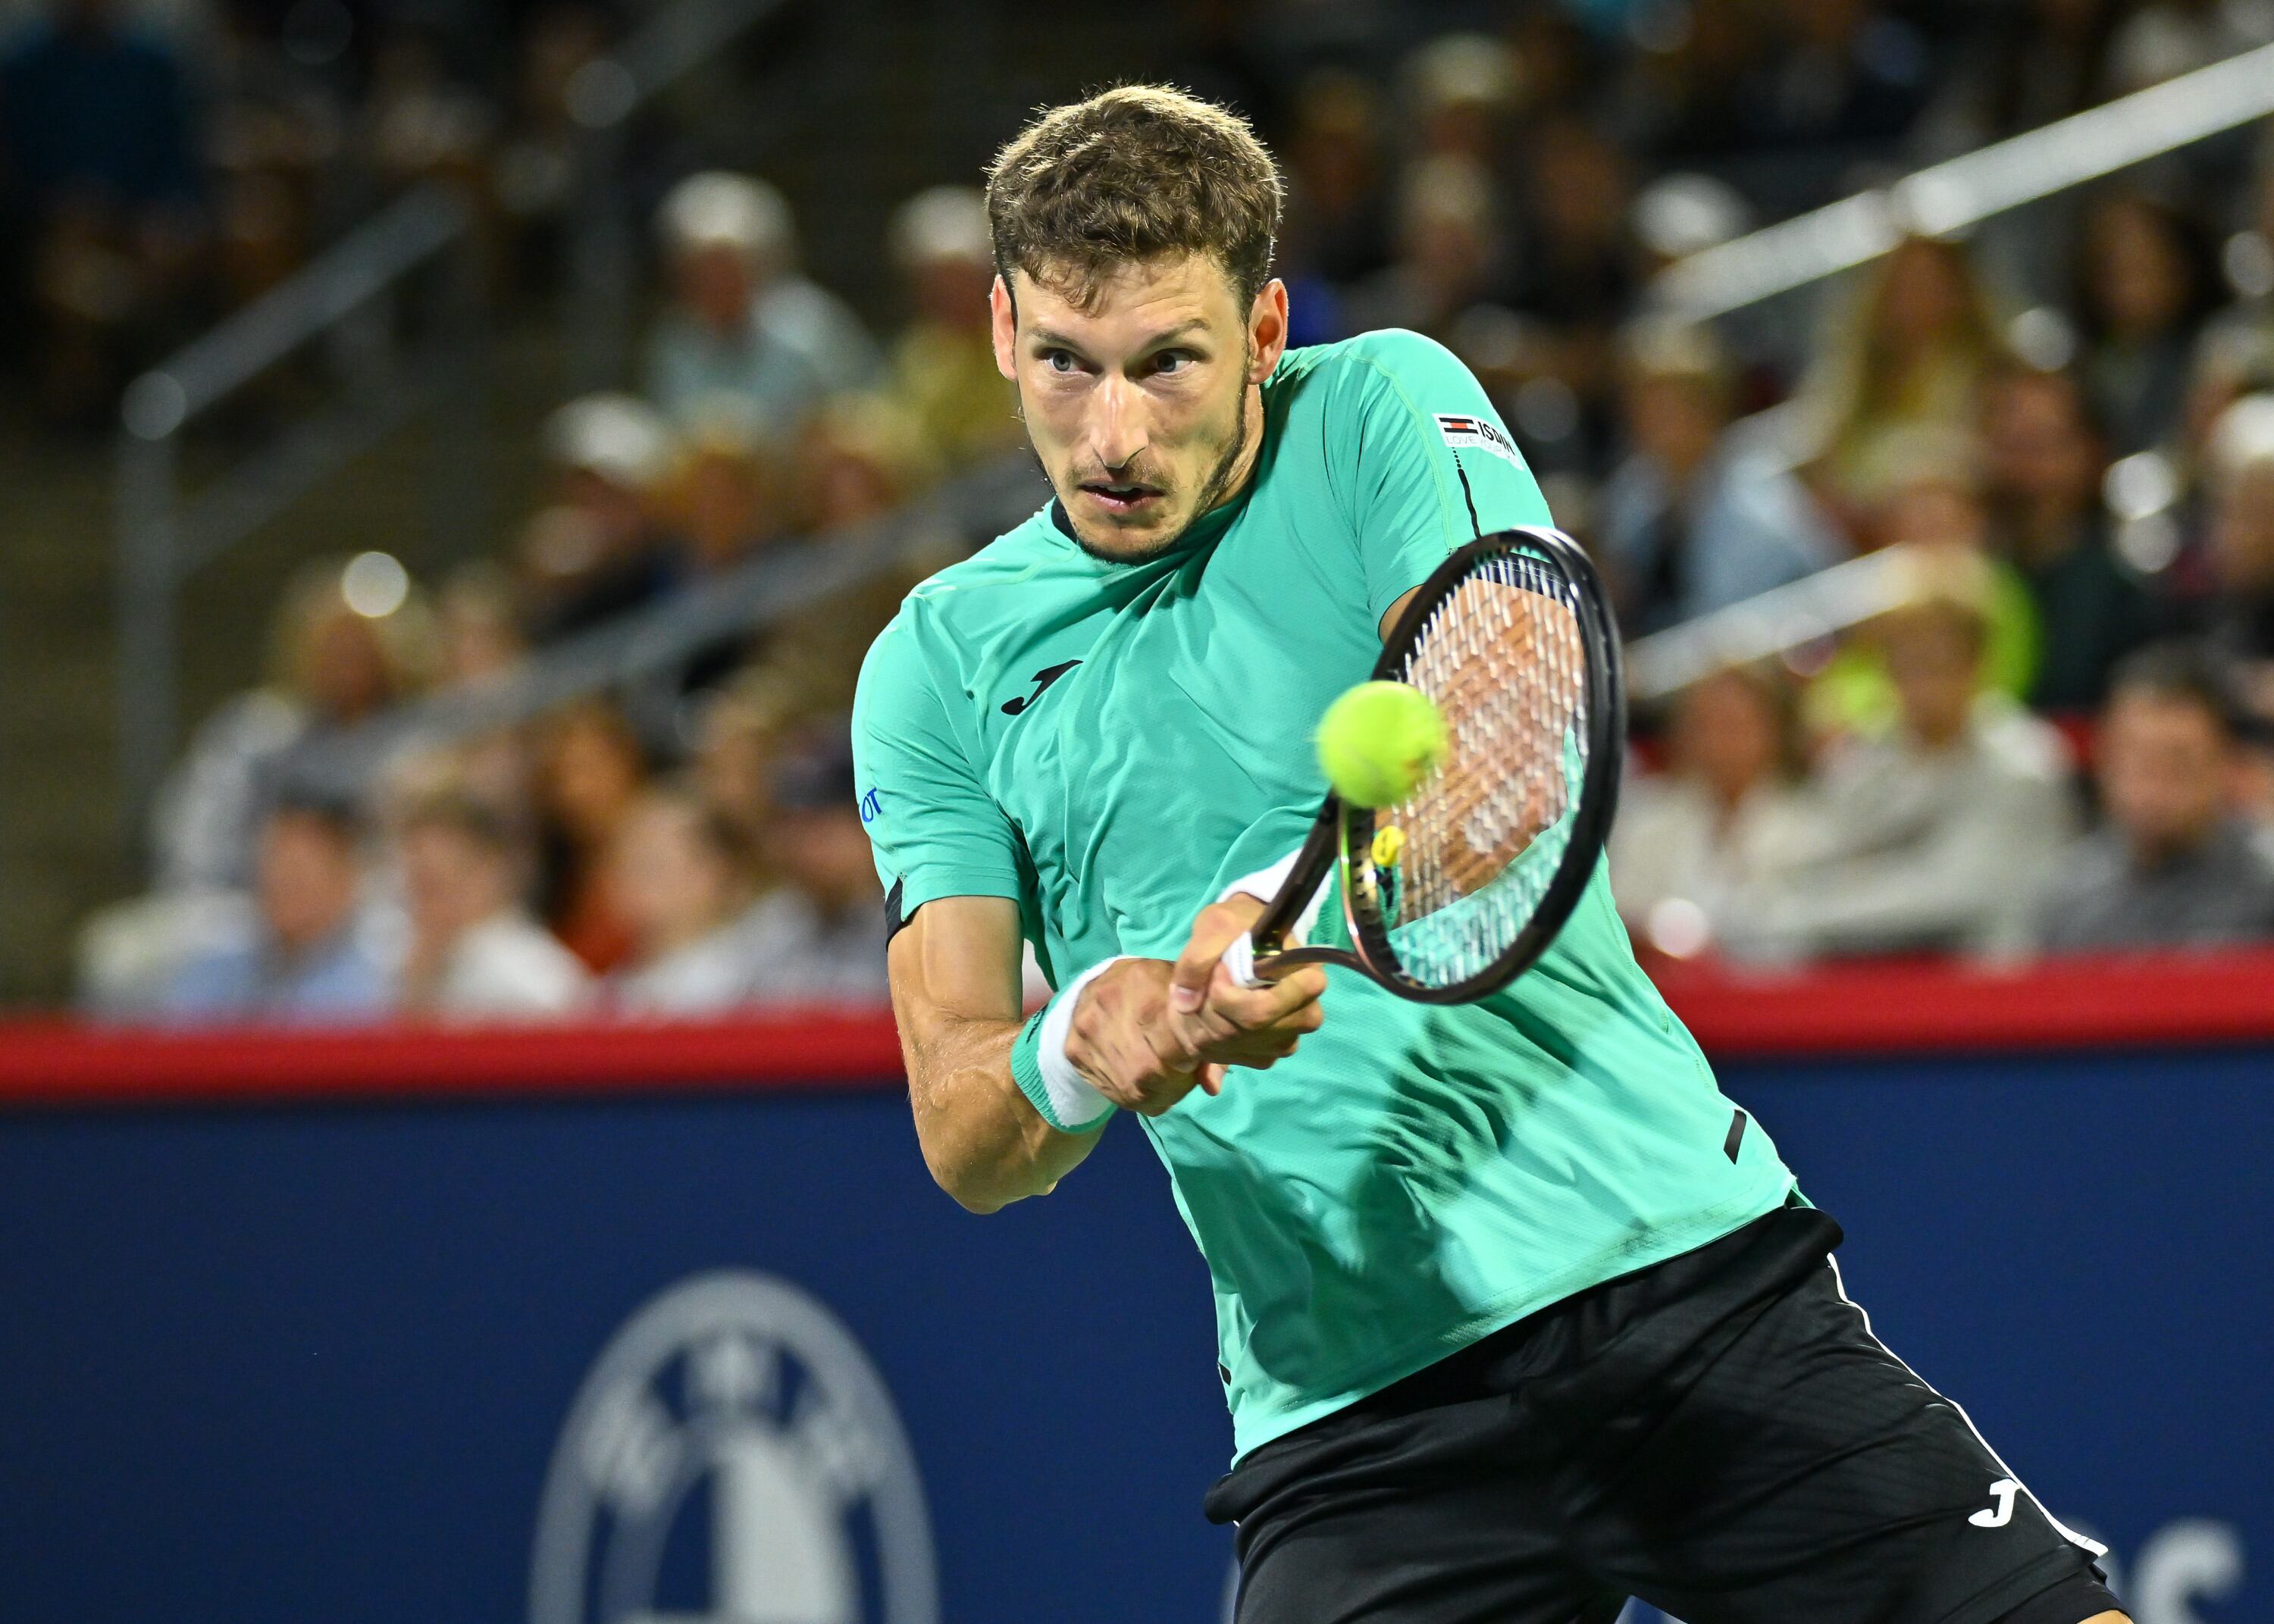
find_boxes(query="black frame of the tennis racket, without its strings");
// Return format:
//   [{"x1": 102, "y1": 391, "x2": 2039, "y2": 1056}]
[{"x1": 1248, "y1": 525, "x2": 1626, "y2": 1003}]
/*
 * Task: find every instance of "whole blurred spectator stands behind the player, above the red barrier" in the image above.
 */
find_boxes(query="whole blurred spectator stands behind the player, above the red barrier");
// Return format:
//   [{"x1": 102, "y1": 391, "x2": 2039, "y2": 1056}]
[{"x1": 13, "y1": 0, "x2": 2274, "y2": 1012}]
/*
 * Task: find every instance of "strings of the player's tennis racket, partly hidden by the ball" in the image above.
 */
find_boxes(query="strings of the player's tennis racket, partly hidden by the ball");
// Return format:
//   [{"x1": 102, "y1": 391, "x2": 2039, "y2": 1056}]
[{"x1": 1373, "y1": 555, "x2": 1587, "y2": 987}]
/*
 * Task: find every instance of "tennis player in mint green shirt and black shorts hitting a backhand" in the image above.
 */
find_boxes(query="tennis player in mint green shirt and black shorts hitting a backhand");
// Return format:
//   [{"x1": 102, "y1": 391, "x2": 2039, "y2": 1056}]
[{"x1": 853, "y1": 86, "x2": 2122, "y2": 1624}]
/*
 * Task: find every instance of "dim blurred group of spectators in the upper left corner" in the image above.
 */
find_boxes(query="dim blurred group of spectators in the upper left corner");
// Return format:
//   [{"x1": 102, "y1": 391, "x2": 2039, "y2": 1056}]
[{"x1": 0, "y1": 0, "x2": 655, "y2": 430}]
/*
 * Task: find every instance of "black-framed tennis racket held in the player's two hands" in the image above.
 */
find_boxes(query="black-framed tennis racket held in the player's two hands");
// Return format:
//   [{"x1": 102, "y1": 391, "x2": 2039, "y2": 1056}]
[{"x1": 1226, "y1": 527, "x2": 1626, "y2": 1003}]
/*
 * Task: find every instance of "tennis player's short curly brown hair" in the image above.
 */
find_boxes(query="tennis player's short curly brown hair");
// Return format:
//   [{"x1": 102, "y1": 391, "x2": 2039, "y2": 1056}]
[{"x1": 987, "y1": 84, "x2": 1280, "y2": 314}]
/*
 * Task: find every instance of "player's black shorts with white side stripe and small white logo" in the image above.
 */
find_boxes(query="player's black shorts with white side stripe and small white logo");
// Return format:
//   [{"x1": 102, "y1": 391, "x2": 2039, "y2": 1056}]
[{"x1": 1207, "y1": 1206, "x2": 2117, "y2": 1624}]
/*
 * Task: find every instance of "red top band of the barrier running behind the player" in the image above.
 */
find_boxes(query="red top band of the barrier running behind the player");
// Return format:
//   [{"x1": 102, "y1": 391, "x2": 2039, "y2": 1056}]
[{"x1": 0, "y1": 951, "x2": 2274, "y2": 1106}]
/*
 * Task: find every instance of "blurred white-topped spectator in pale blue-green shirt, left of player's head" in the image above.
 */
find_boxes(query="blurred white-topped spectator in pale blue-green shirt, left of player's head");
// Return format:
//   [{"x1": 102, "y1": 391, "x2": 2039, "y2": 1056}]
[{"x1": 646, "y1": 171, "x2": 878, "y2": 439}]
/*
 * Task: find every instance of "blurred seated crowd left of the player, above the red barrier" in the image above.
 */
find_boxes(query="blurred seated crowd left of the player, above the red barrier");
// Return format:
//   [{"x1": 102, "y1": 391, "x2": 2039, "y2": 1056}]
[{"x1": 82, "y1": 155, "x2": 1021, "y2": 1022}]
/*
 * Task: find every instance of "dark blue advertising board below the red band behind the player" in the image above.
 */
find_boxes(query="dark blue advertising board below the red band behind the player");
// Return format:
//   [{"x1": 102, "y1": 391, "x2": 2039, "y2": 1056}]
[{"x1": 0, "y1": 1049, "x2": 2274, "y2": 1624}]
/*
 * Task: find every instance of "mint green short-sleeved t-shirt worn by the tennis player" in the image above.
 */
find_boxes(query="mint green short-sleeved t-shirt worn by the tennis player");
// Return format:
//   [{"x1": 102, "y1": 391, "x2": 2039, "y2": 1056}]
[{"x1": 853, "y1": 332, "x2": 1792, "y2": 1453}]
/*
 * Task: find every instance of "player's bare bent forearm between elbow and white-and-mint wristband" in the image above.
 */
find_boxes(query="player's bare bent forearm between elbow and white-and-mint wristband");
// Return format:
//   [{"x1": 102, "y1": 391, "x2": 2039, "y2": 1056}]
[{"x1": 907, "y1": 1017, "x2": 1098, "y2": 1213}]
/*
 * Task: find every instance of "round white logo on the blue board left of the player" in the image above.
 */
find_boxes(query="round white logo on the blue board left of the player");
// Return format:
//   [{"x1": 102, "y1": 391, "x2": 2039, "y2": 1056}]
[{"x1": 530, "y1": 1272, "x2": 939, "y2": 1624}]
